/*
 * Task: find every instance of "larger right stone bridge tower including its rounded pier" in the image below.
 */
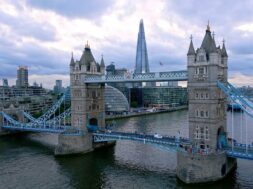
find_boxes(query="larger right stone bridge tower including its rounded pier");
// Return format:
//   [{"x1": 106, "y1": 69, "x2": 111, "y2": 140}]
[{"x1": 177, "y1": 24, "x2": 236, "y2": 183}]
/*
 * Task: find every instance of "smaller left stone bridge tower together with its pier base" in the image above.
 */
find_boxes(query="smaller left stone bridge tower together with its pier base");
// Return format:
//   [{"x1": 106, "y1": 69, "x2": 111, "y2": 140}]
[{"x1": 55, "y1": 42, "x2": 105, "y2": 155}]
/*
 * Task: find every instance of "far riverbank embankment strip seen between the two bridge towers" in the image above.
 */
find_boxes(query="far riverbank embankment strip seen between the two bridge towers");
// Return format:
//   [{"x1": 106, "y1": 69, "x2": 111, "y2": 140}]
[{"x1": 105, "y1": 105, "x2": 188, "y2": 120}]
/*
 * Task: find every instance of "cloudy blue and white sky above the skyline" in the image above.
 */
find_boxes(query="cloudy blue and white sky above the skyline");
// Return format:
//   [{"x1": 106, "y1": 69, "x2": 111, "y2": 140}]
[{"x1": 0, "y1": 0, "x2": 253, "y2": 88}]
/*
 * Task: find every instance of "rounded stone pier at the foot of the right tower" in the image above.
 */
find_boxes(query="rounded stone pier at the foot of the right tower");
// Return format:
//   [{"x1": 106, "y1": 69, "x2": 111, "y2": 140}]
[{"x1": 177, "y1": 151, "x2": 236, "y2": 184}]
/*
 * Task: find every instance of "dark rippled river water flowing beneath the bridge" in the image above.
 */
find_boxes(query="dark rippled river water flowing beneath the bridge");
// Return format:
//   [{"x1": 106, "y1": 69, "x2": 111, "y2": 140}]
[{"x1": 0, "y1": 110, "x2": 253, "y2": 189}]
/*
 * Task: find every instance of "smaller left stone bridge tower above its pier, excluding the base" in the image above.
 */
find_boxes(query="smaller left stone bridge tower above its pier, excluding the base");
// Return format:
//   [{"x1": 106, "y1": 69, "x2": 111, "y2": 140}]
[{"x1": 70, "y1": 44, "x2": 105, "y2": 131}]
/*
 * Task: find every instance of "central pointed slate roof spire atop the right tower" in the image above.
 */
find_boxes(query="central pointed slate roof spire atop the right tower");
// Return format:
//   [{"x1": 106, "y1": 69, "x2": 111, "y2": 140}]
[{"x1": 200, "y1": 22, "x2": 216, "y2": 53}]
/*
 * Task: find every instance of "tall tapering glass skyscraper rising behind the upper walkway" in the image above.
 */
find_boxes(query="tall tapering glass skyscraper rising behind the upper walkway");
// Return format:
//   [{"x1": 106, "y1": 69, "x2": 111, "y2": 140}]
[{"x1": 134, "y1": 19, "x2": 149, "y2": 73}]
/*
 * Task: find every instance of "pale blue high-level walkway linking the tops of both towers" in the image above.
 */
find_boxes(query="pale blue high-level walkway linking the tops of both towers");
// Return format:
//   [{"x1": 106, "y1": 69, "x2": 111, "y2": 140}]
[{"x1": 83, "y1": 70, "x2": 188, "y2": 83}]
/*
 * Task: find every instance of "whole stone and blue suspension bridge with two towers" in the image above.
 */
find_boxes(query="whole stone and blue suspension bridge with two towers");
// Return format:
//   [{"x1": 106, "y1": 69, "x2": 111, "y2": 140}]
[{"x1": 0, "y1": 25, "x2": 253, "y2": 183}]
